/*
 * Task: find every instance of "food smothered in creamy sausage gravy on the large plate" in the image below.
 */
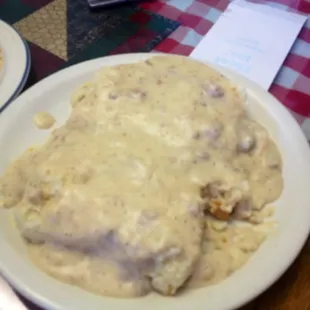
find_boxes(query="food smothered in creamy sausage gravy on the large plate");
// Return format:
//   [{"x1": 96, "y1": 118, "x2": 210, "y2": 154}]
[{"x1": 0, "y1": 56, "x2": 283, "y2": 297}]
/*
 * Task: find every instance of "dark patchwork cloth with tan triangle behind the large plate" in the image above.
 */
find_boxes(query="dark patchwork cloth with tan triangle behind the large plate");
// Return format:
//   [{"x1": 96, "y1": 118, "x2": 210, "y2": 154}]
[{"x1": 0, "y1": 0, "x2": 179, "y2": 83}]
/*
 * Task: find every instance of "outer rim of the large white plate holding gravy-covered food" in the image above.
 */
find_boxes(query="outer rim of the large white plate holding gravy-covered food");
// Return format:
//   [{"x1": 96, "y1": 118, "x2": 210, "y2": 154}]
[{"x1": 0, "y1": 53, "x2": 310, "y2": 310}]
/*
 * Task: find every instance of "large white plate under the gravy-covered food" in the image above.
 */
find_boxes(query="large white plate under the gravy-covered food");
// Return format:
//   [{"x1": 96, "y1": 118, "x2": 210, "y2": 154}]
[{"x1": 0, "y1": 54, "x2": 310, "y2": 310}]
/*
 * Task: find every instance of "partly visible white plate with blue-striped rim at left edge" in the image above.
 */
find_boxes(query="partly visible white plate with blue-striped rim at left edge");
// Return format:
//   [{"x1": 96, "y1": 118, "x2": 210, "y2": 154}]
[{"x1": 0, "y1": 20, "x2": 31, "y2": 112}]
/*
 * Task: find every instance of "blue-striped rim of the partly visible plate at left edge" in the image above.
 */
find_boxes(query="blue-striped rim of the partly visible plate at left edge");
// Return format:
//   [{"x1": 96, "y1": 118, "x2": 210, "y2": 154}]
[{"x1": 0, "y1": 19, "x2": 31, "y2": 113}]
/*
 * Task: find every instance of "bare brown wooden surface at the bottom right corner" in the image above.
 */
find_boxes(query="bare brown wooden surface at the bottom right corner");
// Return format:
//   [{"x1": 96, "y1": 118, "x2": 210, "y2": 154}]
[{"x1": 240, "y1": 239, "x2": 310, "y2": 310}]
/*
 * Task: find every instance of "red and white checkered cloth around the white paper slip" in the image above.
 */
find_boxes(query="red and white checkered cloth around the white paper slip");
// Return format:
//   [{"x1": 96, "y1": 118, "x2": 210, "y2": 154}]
[{"x1": 142, "y1": 0, "x2": 310, "y2": 140}]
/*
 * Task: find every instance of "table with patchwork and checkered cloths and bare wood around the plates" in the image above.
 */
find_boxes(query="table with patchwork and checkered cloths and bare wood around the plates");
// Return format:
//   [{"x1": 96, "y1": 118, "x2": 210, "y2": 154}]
[{"x1": 0, "y1": 0, "x2": 310, "y2": 310}]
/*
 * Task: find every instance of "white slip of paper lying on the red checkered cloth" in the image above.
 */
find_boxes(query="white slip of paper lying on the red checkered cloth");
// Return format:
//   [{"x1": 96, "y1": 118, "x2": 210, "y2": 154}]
[{"x1": 190, "y1": 0, "x2": 307, "y2": 89}]
